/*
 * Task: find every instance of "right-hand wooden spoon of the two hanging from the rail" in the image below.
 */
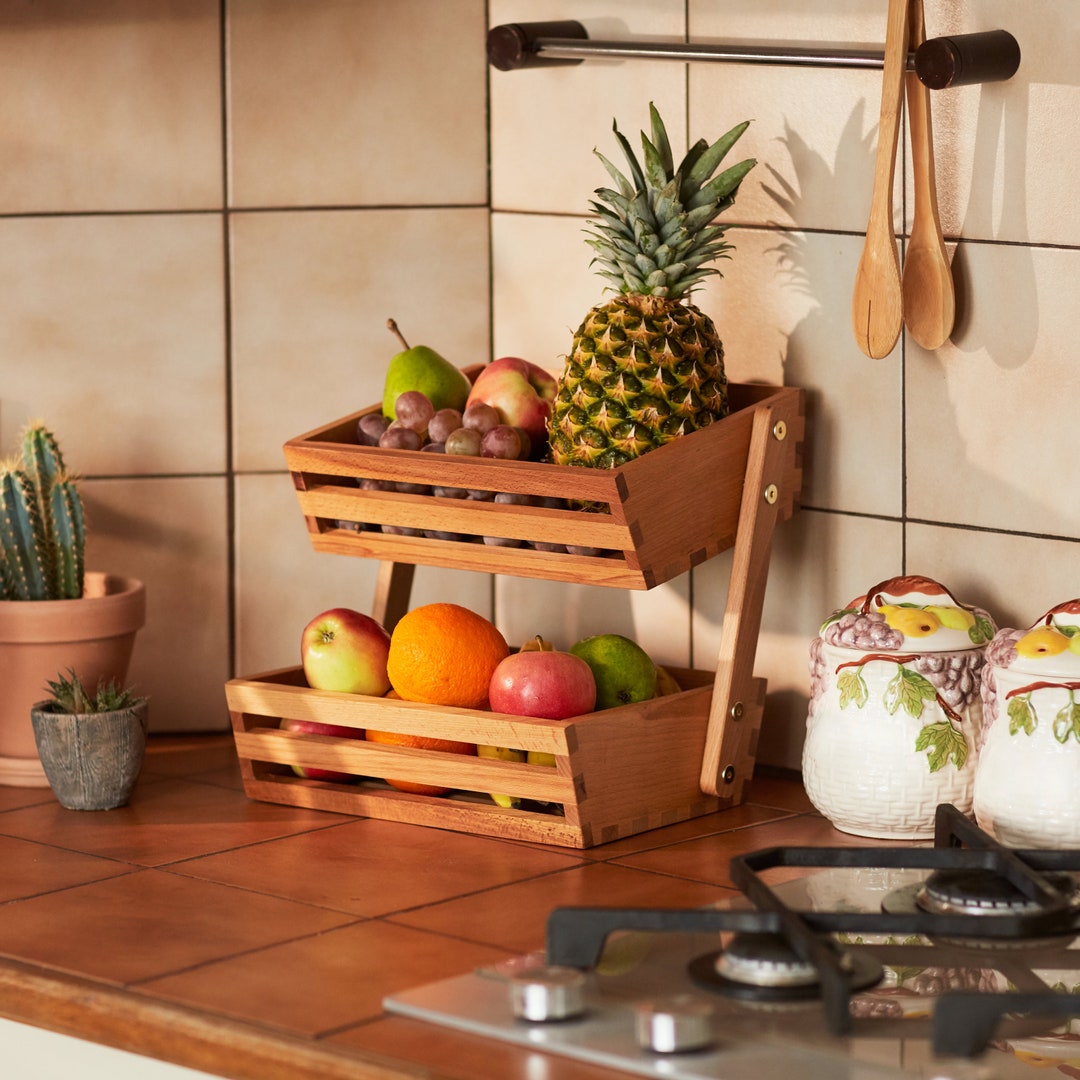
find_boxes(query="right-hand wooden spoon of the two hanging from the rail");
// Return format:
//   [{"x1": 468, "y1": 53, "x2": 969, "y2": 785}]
[{"x1": 903, "y1": 0, "x2": 956, "y2": 350}]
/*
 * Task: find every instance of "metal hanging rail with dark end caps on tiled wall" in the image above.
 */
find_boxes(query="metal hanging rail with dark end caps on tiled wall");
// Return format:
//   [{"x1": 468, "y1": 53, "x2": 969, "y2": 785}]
[{"x1": 487, "y1": 21, "x2": 1021, "y2": 90}]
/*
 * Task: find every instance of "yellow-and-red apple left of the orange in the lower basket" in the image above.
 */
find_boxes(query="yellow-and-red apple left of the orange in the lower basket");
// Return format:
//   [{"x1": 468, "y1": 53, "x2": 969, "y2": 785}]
[{"x1": 300, "y1": 608, "x2": 390, "y2": 698}]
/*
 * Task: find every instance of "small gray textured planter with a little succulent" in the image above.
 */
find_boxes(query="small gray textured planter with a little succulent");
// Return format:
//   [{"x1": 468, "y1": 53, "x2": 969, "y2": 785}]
[{"x1": 30, "y1": 701, "x2": 148, "y2": 810}]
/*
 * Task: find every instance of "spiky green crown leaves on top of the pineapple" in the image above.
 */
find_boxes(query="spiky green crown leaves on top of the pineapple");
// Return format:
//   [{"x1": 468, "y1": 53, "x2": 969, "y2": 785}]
[{"x1": 585, "y1": 104, "x2": 757, "y2": 299}]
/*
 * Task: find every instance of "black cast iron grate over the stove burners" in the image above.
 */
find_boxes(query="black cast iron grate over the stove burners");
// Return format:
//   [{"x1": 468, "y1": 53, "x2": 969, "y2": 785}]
[{"x1": 546, "y1": 804, "x2": 1080, "y2": 1057}]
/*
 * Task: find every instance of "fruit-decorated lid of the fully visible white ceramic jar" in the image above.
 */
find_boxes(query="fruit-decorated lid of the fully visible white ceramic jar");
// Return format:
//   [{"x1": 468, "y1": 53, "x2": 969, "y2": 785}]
[{"x1": 819, "y1": 576, "x2": 993, "y2": 660}]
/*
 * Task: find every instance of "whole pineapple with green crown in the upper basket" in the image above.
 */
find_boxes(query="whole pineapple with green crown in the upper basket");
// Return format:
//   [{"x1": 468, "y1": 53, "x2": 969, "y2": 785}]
[{"x1": 549, "y1": 104, "x2": 756, "y2": 468}]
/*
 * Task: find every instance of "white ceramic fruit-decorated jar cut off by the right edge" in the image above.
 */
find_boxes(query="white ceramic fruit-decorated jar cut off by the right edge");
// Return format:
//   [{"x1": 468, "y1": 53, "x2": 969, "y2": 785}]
[{"x1": 974, "y1": 599, "x2": 1080, "y2": 848}]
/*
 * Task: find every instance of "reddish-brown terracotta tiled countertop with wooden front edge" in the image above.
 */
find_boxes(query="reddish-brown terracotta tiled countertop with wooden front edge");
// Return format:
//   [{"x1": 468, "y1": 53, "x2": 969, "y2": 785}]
[{"x1": 0, "y1": 737, "x2": 854, "y2": 1080}]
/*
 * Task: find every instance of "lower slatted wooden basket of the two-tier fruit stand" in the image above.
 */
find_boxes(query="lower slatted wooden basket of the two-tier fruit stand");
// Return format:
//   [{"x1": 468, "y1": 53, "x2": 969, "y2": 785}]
[{"x1": 226, "y1": 667, "x2": 765, "y2": 848}]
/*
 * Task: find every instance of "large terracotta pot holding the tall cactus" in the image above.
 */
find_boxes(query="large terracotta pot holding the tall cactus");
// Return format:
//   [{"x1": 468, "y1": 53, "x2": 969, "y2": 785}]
[{"x1": 0, "y1": 572, "x2": 146, "y2": 787}]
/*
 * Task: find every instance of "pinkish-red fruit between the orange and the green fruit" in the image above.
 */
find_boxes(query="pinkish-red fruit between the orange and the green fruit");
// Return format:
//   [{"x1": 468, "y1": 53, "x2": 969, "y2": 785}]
[{"x1": 488, "y1": 649, "x2": 596, "y2": 720}]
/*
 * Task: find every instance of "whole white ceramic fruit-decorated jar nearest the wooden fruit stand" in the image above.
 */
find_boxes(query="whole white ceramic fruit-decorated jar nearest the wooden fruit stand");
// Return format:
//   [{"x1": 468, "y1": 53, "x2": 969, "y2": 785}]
[{"x1": 802, "y1": 577, "x2": 995, "y2": 840}]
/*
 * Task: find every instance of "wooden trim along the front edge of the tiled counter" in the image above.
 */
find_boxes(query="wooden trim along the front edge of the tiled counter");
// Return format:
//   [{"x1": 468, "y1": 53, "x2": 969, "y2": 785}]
[{"x1": 0, "y1": 958, "x2": 438, "y2": 1080}]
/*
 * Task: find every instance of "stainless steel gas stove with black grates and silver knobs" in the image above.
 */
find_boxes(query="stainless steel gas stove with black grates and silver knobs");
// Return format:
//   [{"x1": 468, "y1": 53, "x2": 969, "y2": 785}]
[{"x1": 384, "y1": 805, "x2": 1080, "y2": 1080}]
